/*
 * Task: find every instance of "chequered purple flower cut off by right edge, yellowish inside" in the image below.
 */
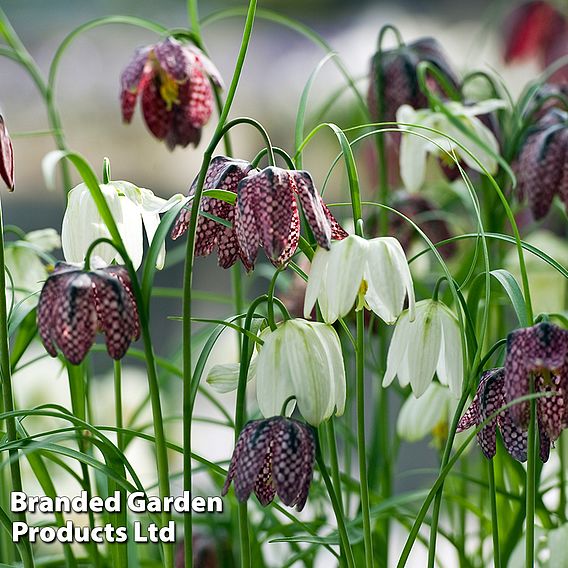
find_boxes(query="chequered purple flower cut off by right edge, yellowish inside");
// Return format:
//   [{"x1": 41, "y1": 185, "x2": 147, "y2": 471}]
[{"x1": 504, "y1": 322, "x2": 568, "y2": 445}]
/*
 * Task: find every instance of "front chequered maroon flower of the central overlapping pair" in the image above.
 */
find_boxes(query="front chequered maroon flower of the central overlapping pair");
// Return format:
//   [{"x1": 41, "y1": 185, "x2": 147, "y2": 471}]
[{"x1": 235, "y1": 166, "x2": 347, "y2": 270}]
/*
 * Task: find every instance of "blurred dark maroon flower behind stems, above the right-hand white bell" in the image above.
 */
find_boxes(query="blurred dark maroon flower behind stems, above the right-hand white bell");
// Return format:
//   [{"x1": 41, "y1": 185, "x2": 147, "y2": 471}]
[{"x1": 391, "y1": 193, "x2": 456, "y2": 258}]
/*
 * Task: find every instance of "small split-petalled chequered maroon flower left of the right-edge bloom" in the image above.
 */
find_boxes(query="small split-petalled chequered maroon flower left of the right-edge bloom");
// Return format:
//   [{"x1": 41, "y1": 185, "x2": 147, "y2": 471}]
[{"x1": 457, "y1": 368, "x2": 528, "y2": 462}]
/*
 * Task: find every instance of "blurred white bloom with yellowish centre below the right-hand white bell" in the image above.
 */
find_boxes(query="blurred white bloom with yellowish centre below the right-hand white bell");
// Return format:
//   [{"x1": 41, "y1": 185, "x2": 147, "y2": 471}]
[{"x1": 396, "y1": 382, "x2": 457, "y2": 442}]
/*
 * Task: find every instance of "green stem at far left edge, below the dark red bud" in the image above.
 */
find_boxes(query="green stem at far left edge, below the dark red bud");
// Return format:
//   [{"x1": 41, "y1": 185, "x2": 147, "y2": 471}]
[{"x1": 0, "y1": 204, "x2": 34, "y2": 568}]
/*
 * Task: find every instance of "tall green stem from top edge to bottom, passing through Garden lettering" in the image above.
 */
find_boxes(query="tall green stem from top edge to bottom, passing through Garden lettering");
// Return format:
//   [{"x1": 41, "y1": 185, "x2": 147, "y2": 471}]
[{"x1": 182, "y1": 4, "x2": 256, "y2": 568}]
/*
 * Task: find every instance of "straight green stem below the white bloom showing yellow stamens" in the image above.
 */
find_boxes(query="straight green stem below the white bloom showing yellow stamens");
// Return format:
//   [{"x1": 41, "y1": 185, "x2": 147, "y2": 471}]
[{"x1": 356, "y1": 310, "x2": 373, "y2": 568}]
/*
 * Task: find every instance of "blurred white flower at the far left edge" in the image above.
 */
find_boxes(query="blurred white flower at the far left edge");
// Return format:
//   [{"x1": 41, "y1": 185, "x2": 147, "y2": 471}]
[{"x1": 5, "y1": 229, "x2": 61, "y2": 305}]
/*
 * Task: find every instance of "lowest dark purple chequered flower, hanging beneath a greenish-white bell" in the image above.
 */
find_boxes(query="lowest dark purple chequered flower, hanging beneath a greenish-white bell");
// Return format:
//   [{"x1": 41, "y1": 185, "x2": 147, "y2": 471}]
[{"x1": 221, "y1": 416, "x2": 315, "y2": 511}]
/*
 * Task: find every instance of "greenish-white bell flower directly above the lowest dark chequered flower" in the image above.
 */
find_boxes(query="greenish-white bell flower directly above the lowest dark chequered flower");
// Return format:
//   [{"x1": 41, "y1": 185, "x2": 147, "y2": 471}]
[{"x1": 256, "y1": 318, "x2": 345, "y2": 426}]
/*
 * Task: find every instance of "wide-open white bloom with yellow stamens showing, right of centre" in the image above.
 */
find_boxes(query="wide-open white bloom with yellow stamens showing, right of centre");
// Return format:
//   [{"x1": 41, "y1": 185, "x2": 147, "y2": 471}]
[{"x1": 304, "y1": 235, "x2": 414, "y2": 324}]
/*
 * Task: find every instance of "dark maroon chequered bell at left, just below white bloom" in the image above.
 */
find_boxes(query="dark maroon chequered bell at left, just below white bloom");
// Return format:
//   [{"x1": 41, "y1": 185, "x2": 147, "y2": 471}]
[{"x1": 37, "y1": 262, "x2": 140, "y2": 365}]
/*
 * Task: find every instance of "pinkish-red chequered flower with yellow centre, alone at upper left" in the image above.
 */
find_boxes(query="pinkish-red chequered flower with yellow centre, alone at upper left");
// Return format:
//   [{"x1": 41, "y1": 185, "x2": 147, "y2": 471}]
[{"x1": 120, "y1": 37, "x2": 222, "y2": 150}]
